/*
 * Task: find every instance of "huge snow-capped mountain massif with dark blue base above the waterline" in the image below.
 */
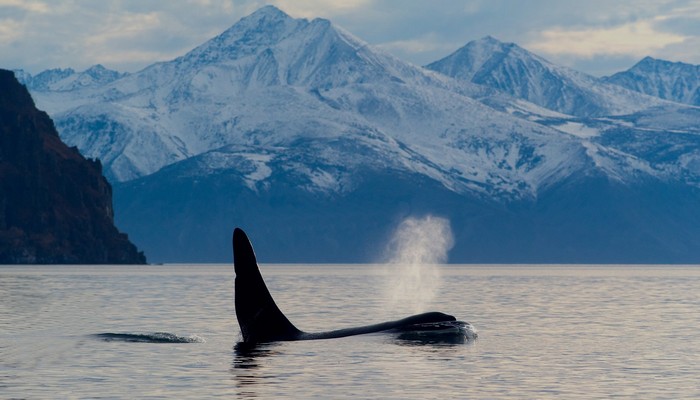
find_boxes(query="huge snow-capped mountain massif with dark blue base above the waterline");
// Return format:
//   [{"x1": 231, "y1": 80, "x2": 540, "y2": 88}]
[{"x1": 17, "y1": 6, "x2": 700, "y2": 262}]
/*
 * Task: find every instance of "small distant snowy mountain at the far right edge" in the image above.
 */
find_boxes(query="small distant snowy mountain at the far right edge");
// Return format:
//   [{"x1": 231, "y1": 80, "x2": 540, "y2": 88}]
[{"x1": 605, "y1": 57, "x2": 700, "y2": 106}]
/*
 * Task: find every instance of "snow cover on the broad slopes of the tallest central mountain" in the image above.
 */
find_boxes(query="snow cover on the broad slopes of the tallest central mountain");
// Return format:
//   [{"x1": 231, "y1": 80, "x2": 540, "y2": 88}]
[{"x1": 27, "y1": 6, "x2": 600, "y2": 196}]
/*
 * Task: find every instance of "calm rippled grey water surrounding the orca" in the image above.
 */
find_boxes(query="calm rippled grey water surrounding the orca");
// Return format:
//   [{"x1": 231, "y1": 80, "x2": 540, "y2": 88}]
[{"x1": 0, "y1": 265, "x2": 700, "y2": 399}]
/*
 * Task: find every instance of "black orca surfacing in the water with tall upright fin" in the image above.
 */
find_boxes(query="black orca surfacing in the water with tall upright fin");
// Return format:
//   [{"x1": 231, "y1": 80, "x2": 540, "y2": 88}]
[{"x1": 232, "y1": 228, "x2": 476, "y2": 344}]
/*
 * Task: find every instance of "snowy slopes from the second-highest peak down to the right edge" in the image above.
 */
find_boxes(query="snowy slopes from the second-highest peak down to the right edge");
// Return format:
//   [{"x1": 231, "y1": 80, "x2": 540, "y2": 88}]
[{"x1": 427, "y1": 37, "x2": 700, "y2": 186}]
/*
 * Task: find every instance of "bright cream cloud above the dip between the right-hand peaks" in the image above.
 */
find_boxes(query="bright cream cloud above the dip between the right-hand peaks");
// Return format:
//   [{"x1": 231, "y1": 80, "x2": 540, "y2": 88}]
[{"x1": 525, "y1": 18, "x2": 687, "y2": 57}]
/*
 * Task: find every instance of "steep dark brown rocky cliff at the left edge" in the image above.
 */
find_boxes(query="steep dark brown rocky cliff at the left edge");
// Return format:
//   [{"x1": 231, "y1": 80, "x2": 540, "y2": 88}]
[{"x1": 0, "y1": 70, "x2": 146, "y2": 264}]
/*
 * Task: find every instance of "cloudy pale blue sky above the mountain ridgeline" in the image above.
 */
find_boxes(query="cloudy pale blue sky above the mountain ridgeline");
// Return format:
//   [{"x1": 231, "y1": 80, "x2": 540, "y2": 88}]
[{"x1": 0, "y1": 0, "x2": 700, "y2": 76}]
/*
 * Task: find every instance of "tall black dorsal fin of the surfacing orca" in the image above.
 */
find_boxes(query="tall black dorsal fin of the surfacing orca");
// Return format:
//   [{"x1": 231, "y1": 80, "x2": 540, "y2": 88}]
[{"x1": 233, "y1": 228, "x2": 302, "y2": 343}]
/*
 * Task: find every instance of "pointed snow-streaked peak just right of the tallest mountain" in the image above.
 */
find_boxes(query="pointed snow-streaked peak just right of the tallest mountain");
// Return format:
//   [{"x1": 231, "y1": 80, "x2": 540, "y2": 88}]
[{"x1": 426, "y1": 36, "x2": 662, "y2": 117}]
